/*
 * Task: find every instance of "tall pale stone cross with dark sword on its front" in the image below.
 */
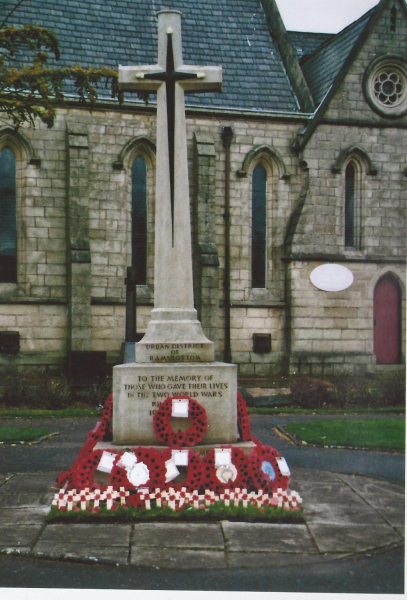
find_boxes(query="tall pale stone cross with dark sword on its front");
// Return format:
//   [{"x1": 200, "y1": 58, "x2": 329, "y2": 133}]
[{"x1": 119, "y1": 10, "x2": 222, "y2": 362}]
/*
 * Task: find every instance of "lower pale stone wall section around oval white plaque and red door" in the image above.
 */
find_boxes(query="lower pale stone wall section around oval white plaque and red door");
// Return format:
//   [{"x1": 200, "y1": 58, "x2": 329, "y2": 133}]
[{"x1": 290, "y1": 261, "x2": 406, "y2": 376}]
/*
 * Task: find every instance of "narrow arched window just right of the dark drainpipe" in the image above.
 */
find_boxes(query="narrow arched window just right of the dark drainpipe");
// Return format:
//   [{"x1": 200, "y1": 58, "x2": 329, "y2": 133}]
[{"x1": 252, "y1": 164, "x2": 267, "y2": 288}]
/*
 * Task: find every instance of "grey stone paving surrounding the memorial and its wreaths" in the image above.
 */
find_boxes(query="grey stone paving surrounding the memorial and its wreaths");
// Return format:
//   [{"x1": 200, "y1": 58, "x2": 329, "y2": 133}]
[{"x1": 0, "y1": 416, "x2": 404, "y2": 572}]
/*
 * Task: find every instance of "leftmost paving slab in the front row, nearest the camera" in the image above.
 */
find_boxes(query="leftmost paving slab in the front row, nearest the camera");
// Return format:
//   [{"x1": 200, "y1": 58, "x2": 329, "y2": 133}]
[{"x1": 32, "y1": 542, "x2": 129, "y2": 565}]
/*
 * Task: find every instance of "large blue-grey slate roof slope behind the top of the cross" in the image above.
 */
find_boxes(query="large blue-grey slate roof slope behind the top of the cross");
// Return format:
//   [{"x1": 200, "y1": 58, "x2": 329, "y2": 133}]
[{"x1": 0, "y1": 0, "x2": 299, "y2": 112}]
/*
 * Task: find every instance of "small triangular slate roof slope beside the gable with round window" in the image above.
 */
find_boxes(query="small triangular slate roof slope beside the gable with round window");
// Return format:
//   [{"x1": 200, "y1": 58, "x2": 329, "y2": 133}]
[{"x1": 300, "y1": 7, "x2": 377, "y2": 106}]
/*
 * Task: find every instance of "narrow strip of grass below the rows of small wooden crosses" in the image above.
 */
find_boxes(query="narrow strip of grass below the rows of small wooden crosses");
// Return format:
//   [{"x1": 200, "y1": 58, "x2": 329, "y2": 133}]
[{"x1": 46, "y1": 504, "x2": 304, "y2": 523}]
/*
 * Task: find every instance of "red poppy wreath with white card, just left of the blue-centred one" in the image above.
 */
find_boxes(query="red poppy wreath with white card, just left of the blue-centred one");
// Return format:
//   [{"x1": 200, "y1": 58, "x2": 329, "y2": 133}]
[{"x1": 203, "y1": 446, "x2": 251, "y2": 493}]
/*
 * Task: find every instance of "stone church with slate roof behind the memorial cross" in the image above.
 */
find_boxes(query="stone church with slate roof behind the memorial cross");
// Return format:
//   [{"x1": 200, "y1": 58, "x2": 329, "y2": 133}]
[{"x1": 0, "y1": 0, "x2": 407, "y2": 377}]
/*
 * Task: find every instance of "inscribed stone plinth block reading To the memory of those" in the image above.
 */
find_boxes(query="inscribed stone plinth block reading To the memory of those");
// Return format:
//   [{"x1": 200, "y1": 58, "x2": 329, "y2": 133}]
[{"x1": 113, "y1": 363, "x2": 238, "y2": 445}]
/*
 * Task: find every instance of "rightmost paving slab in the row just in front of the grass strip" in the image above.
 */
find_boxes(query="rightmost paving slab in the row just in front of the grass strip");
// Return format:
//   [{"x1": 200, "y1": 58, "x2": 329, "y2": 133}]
[{"x1": 308, "y1": 523, "x2": 403, "y2": 552}]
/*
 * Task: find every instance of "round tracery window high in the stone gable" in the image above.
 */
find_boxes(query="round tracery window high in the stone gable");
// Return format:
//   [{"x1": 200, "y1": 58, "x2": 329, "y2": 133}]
[{"x1": 365, "y1": 56, "x2": 407, "y2": 117}]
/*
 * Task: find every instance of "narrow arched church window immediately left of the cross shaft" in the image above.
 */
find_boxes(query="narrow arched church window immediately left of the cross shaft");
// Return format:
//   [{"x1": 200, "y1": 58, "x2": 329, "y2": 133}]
[{"x1": 131, "y1": 156, "x2": 147, "y2": 285}]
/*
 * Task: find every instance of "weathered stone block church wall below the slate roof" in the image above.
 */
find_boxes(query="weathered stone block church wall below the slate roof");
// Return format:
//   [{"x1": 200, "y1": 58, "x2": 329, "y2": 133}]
[{"x1": 0, "y1": 82, "x2": 405, "y2": 376}]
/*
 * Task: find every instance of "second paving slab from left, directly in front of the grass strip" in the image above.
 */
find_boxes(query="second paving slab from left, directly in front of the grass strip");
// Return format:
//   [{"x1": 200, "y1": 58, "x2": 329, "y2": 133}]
[{"x1": 133, "y1": 523, "x2": 225, "y2": 550}]
